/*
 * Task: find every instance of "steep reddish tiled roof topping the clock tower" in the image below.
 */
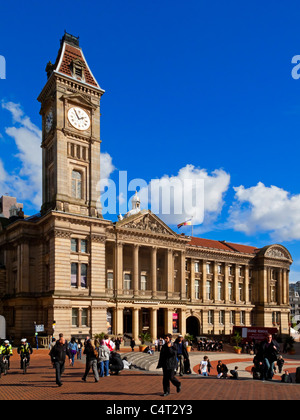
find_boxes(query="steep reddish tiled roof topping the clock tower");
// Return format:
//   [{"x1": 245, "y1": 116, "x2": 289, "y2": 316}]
[{"x1": 46, "y1": 32, "x2": 102, "y2": 90}]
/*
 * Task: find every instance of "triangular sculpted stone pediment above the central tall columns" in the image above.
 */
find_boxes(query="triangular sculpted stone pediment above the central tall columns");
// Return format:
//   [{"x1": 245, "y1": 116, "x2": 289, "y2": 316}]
[{"x1": 116, "y1": 211, "x2": 178, "y2": 238}]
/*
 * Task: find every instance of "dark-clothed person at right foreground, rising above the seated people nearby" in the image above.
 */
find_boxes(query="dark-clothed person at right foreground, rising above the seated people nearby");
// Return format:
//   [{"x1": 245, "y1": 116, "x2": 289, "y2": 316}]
[{"x1": 257, "y1": 334, "x2": 279, "y2": 381}]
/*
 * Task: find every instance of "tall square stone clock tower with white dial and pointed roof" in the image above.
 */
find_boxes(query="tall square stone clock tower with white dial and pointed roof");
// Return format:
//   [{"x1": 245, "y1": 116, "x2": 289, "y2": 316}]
[{"x1": 38, "y1": 33, "x2": 104, "y2": 217}]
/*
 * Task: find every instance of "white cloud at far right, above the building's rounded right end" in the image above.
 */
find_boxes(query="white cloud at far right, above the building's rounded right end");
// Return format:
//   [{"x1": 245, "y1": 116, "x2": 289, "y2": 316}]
[{"x1": 229, "y1": 182, "x2": 300, "y2": 241}]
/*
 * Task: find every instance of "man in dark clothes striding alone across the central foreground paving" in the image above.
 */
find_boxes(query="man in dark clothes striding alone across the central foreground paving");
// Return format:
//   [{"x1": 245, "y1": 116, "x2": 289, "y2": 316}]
[{"x1": 156, "y1": 334, "x2": 181, "y2": 397}]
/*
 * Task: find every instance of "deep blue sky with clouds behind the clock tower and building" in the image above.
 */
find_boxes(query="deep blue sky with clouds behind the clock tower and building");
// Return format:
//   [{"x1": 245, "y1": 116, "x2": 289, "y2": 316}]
[{"x1": 0, "y1": 0, "x2": 300, "y2": 281}]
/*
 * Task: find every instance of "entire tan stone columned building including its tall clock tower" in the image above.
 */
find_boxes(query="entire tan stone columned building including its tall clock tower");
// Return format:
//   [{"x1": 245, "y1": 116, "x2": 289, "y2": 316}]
[{"x1": 0, "y1": 34, "x2": 292, "y2": 341}]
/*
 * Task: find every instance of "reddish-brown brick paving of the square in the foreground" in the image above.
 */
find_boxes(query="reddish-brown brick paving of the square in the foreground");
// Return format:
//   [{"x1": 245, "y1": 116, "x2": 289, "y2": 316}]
[{"x1": 0, "y1": 349, "x2": 300, "y2": 403}]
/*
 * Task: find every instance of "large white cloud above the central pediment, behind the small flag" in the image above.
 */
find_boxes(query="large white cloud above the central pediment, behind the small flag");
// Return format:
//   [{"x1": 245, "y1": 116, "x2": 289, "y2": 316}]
[{"x1": 139, "y1": 165, "x2": 230, "y2": 226}]
